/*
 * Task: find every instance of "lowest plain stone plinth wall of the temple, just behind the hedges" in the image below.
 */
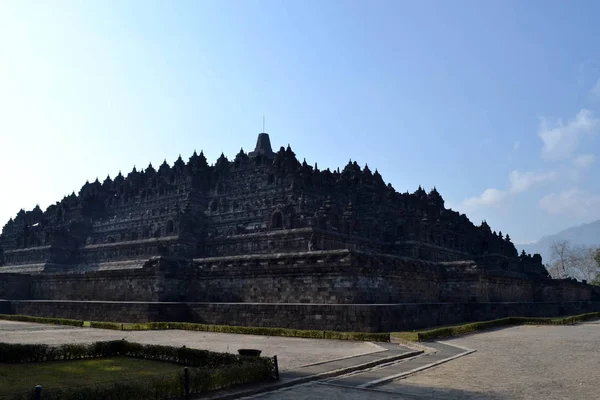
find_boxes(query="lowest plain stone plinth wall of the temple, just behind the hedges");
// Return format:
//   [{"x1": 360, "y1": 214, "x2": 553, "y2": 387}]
[{"x1": 8, "y1": 300, "x2": 600, "y2": 332}]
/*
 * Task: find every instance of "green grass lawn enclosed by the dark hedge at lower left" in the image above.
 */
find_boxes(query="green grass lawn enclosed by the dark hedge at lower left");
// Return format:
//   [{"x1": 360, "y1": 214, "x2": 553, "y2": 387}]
[{"x1": 0, "y1": 357, "x2": 183, "y2": 395}]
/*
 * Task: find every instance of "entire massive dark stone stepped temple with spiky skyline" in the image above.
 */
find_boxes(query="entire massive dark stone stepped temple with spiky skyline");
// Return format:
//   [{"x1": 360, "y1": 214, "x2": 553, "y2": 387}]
[{"x1": 0, "y1": 133, "x2": 600, "y2": 331}]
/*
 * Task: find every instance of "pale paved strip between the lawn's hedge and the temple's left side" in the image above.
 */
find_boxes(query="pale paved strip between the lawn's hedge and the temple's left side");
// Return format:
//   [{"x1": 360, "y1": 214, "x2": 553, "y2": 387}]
[{"x1": 0, "y1": 321, "x2": 384, "y2": 371}]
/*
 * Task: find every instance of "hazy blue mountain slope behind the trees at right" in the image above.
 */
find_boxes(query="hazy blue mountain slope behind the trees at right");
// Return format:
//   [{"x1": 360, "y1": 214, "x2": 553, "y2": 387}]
[{"x1": 516, "y1": 220, "x2": 600, "y2": 264}]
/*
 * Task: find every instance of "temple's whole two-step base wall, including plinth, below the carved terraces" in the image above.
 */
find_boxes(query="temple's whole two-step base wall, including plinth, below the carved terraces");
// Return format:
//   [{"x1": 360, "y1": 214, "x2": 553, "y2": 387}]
[{"x1": 0, "y1": 250, "x2": 600, "y2": 331}]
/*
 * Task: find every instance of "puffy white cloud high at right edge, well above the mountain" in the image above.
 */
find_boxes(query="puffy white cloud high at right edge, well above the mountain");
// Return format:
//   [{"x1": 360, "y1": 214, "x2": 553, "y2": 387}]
[{"x1": 538, "y1": 109, "x2": 600, "y2": 160}]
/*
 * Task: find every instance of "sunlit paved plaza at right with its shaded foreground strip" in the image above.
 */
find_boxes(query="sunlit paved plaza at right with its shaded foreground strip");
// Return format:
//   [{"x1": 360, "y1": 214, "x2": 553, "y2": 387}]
[{"x1": 247, "y1": 322, "x2": 600, "y2": 400}]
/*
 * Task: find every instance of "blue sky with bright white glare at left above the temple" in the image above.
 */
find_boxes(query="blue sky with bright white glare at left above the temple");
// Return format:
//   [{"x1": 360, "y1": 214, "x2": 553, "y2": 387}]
[{"x1": 0, "y1": 0, "x2": 600, "y2": 243}]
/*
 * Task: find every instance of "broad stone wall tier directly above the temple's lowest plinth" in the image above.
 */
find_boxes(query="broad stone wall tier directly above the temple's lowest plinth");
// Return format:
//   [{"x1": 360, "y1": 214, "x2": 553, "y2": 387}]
[{"x1": 0, "y1": 250, "x2": 593, "y2": 304}]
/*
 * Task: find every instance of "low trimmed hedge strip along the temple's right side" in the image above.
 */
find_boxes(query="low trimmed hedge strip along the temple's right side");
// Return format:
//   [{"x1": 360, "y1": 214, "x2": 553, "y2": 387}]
[{"x1": 393, "y1": 312, "x2": 600, "y2": 342}]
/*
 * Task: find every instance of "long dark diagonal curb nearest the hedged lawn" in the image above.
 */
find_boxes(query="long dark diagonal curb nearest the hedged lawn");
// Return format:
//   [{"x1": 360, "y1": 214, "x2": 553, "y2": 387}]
[{"x1": 198, "y1": 350, "x2": 423, "y2": 400}]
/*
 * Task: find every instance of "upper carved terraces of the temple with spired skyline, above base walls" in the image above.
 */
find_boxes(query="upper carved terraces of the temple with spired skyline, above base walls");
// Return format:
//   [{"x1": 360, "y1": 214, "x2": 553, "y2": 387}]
[{"x1": 0, "y1": 133, "x2": 545, "y2": 278}]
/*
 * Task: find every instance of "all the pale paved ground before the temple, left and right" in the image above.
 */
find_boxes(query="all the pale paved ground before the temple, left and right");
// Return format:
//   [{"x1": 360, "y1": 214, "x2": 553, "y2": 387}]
[{"x1": 0, "y1": 321, "x2": 600, "y2": 400}]
